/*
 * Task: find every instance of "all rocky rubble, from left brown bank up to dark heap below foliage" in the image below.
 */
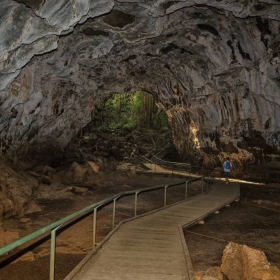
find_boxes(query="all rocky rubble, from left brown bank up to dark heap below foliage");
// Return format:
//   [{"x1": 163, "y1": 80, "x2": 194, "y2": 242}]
[{"x1": 0, "y1": 122, "x2": 170, "y2": 219}]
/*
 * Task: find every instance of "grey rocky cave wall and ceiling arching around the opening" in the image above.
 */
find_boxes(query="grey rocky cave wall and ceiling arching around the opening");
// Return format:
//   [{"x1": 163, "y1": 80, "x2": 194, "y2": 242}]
[{"x1": 0, "y1": 0, "x2": 280, "y2": 173}]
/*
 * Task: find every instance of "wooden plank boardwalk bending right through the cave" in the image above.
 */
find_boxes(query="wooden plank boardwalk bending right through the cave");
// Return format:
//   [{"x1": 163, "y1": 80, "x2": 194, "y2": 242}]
[{"x1": 66, "y1": 181, "x2": 240, "y2": 280}]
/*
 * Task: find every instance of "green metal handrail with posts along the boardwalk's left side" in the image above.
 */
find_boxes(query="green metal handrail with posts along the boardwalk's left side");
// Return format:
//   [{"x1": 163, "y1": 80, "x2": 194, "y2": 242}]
[{"x1": 0, "y1": 174, "x2": 213, "y2": 280}]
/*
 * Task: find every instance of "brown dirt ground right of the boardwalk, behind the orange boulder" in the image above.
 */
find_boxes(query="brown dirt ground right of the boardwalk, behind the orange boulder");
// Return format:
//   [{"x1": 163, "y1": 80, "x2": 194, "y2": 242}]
[{"x1": 184, "y1": 184, "x2": 280, "y2": 271}]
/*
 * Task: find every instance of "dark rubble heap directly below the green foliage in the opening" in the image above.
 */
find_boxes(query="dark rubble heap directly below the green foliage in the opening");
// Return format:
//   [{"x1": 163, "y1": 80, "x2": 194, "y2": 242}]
[{"x1": 65, "y1": 129, "x2": 172, "y2": 163}]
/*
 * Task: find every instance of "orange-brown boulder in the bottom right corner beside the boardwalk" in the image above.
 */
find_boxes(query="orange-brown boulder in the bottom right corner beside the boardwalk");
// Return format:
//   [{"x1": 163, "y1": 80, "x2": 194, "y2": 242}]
[{"x1": 221, "y1": 242, "x2": 280, "y2": 280}]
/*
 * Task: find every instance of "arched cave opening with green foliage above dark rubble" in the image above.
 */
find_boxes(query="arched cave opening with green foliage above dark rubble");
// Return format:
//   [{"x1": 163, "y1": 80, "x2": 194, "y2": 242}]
[{"x1": 75, "y1": 91, "x2": 178, "y2": 161}]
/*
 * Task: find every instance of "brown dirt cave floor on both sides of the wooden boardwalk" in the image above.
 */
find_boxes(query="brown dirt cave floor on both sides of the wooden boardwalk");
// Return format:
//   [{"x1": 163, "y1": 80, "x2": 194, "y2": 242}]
[{"x1": 0, "y1": 175, "x2": 280, "y2": 280}]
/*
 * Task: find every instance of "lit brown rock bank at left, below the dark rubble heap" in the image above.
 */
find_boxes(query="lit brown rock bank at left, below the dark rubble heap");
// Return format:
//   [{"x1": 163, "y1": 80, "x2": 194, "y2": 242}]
[{"x1": 0, "y1": 138, "x2": 147, "y2": 221}]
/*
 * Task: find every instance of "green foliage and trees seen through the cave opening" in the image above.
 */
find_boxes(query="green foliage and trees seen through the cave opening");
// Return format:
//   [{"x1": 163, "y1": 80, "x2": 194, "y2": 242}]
[{"x1": 92, "y1": 91, "x2": 170, "y2": 130}]
